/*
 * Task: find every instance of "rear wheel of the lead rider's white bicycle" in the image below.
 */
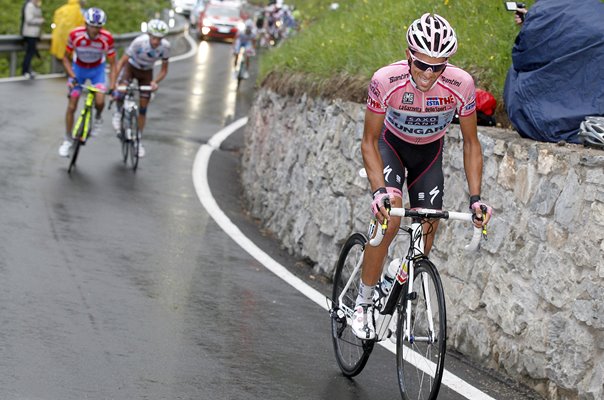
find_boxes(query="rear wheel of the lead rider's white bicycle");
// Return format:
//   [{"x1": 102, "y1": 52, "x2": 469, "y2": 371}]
[{"x1": 331, "y1": 233, "x2": 375, "y2": 377}]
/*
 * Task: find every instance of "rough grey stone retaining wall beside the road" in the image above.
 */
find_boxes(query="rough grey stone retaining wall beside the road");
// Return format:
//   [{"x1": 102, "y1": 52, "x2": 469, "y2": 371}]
[{"x1": 242, "y1": 90, "x2": 604, "y2": 400}]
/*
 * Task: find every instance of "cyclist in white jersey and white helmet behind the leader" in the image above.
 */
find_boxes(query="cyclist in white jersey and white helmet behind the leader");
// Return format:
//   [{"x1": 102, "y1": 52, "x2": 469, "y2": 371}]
[{"x1": 112, "y1": 19, "x2": 170, "y2": 157}]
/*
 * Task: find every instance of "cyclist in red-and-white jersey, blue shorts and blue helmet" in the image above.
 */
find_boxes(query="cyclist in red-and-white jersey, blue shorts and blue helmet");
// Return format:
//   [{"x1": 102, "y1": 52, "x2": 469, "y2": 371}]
[{"x1": 59, "y1": 7, "x2": 117, "y2": 157}]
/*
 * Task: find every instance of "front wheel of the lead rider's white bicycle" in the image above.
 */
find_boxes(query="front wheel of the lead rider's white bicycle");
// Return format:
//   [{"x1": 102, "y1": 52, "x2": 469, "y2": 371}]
[{"x1": 396, "y1": 258, "x2": 447, "y2": 400}]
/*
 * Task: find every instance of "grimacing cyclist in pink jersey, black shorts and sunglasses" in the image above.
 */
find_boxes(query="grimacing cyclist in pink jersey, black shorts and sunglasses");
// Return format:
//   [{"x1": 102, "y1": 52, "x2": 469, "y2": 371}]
[{"x1": 352, "y1": 13, "x2": 491, "y2": 339}]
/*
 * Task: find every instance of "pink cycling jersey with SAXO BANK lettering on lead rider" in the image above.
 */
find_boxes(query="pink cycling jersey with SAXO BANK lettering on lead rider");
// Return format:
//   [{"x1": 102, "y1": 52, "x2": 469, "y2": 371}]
[{"x1": 367, "y1": 61, "x2": 476, "y2": 144}]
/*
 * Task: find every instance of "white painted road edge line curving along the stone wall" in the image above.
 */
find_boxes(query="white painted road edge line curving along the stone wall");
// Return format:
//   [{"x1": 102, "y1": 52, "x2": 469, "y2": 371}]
[{"x1": 193, "y1": 122, "x2": 495, "y2": 400}]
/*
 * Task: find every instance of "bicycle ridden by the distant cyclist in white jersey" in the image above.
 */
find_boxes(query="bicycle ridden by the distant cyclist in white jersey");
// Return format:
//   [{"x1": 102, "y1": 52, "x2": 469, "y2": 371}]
[{"x1": 109, "y1": 82, "x2": 152, "y2": 171}]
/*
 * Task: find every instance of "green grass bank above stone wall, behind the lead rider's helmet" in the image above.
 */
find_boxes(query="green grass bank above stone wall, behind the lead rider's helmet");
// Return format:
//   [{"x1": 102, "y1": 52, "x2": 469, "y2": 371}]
[{"x1": 260, "y1": 0, "x2": 533, "y2": 104}]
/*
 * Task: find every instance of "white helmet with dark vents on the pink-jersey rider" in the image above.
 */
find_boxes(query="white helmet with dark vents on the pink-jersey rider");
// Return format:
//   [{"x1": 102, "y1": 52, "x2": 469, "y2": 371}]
[{"x1": 407, "y1": 13, "x2": 457, "y2": 58}]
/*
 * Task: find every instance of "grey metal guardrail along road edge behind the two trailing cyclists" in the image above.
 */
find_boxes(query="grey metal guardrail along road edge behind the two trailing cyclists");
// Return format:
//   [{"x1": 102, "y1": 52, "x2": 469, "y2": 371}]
[{"x1": 0, "y1": 11, "x2": 187, "y2": 76}]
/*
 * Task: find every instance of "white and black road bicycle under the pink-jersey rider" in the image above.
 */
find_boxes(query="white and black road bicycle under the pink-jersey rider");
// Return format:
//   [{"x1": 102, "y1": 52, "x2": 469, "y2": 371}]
[{"x1": 329, "y1": 203, "x2": 486, "y2": 400}]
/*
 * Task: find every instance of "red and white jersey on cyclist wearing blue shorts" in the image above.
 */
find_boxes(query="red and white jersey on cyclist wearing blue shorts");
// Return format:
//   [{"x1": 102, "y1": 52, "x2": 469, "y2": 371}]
[{"x1": 67, "y1": 26, "x2": 115, "y2": 68}]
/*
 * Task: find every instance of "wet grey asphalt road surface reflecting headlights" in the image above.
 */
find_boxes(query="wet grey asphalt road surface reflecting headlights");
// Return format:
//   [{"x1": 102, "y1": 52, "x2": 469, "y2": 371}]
[{"x1": 0, "y1": 35, "x2": 536, "y2": 400}]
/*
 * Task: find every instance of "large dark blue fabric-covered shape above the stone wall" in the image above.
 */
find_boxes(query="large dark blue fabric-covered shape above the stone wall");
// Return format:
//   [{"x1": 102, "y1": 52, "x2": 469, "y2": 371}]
[{"x1": 503, "y1": 0, "x2": 604, "y2": 143}]
